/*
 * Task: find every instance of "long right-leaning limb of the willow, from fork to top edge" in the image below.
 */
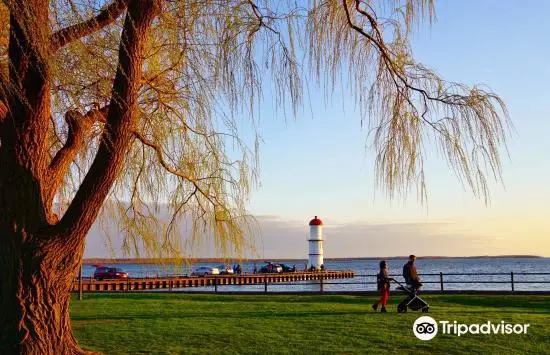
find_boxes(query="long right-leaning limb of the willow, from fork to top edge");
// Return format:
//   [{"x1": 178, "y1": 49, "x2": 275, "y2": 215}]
[{"x1": 54, "y1": 0, "x2": 161, "y2": 237}]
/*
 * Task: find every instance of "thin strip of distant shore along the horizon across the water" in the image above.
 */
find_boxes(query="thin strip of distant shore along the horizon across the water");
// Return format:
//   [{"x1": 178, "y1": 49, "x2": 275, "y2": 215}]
[{"x1": 82, "y1": 255, "x2": 545, "y2": 265}]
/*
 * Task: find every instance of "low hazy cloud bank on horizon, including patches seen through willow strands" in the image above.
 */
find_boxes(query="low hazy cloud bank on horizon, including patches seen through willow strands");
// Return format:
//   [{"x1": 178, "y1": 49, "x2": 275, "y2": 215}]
[{"x1": 85, "y1": 215, "x2": 502, "y2": 259}]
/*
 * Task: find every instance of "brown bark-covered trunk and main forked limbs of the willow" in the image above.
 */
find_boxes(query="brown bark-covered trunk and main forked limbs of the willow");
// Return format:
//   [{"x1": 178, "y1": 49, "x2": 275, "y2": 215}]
[{"x1": 0, "y1": 0, "x2": 160, "y2": 355}]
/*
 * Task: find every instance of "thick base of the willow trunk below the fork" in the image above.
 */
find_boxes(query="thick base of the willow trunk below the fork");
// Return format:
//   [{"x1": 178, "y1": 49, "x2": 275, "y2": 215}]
[{"x1": 0, "y1": 229, "x2": 90, "y2": 355}]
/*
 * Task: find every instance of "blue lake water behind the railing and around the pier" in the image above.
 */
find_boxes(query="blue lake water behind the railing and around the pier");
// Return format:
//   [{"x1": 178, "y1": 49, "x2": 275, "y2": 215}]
[{"x1": 83, "y1": 258, "x2": 550, "y2": 292}]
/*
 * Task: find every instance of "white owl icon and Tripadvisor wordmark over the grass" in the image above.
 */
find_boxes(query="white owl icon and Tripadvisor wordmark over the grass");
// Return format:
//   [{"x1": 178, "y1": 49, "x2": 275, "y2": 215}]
[{"x1": 413, "y1": 316, "x2": 530, "y2": 340}]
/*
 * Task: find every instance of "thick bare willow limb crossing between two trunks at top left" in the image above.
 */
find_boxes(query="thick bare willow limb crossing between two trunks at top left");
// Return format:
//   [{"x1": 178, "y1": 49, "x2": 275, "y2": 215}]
[{"x1": 52, "y1": 0, "x2": 128, "y2": 51}]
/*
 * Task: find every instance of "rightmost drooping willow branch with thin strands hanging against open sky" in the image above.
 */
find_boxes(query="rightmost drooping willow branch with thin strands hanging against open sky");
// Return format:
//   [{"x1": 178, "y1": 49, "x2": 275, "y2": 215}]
[{"x1": 341, "y1": 0, "x2": 509, "y2": 203}]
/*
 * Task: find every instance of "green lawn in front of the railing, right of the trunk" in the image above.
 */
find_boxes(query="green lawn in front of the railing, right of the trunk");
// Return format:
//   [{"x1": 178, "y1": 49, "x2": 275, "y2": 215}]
[{"x1": 71, "y1": 293, "x2": 550, "y2": 354}]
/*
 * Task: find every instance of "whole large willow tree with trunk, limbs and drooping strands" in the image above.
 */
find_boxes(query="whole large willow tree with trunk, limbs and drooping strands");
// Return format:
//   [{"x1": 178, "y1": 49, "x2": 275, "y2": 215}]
[{"x1": 0, "y1": 0, "x2": 507, "y2": 355}]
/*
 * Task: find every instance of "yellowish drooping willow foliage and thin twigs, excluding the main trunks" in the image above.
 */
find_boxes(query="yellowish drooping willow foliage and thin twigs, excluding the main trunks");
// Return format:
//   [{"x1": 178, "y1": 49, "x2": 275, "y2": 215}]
[{"x1": 0, "y1": 0, "x2": 509, "y2": 254}]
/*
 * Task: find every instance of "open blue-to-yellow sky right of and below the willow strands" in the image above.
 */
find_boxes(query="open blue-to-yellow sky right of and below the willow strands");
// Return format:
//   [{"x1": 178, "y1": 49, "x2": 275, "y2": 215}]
[{"x1": 85, "y1": 0, "x2": 550, "y2": 258}]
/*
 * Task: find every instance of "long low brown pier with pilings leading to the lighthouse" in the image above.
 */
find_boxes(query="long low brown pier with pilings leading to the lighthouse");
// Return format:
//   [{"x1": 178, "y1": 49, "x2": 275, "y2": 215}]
[{"x1": 73, "y1": 270, "x2": 355, "y2": 292}]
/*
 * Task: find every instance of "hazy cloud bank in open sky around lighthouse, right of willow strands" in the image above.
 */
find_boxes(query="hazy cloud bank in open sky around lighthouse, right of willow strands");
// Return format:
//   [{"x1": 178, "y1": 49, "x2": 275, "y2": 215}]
[{"x1": 254, "y1": 217, "x2": 500, "y2": 258}]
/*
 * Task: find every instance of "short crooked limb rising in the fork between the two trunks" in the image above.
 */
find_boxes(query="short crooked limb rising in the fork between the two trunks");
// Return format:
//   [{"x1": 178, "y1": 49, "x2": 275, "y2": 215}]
[{"x1": 44, "y1": 105, "x2": 109, "y2": 207}]
